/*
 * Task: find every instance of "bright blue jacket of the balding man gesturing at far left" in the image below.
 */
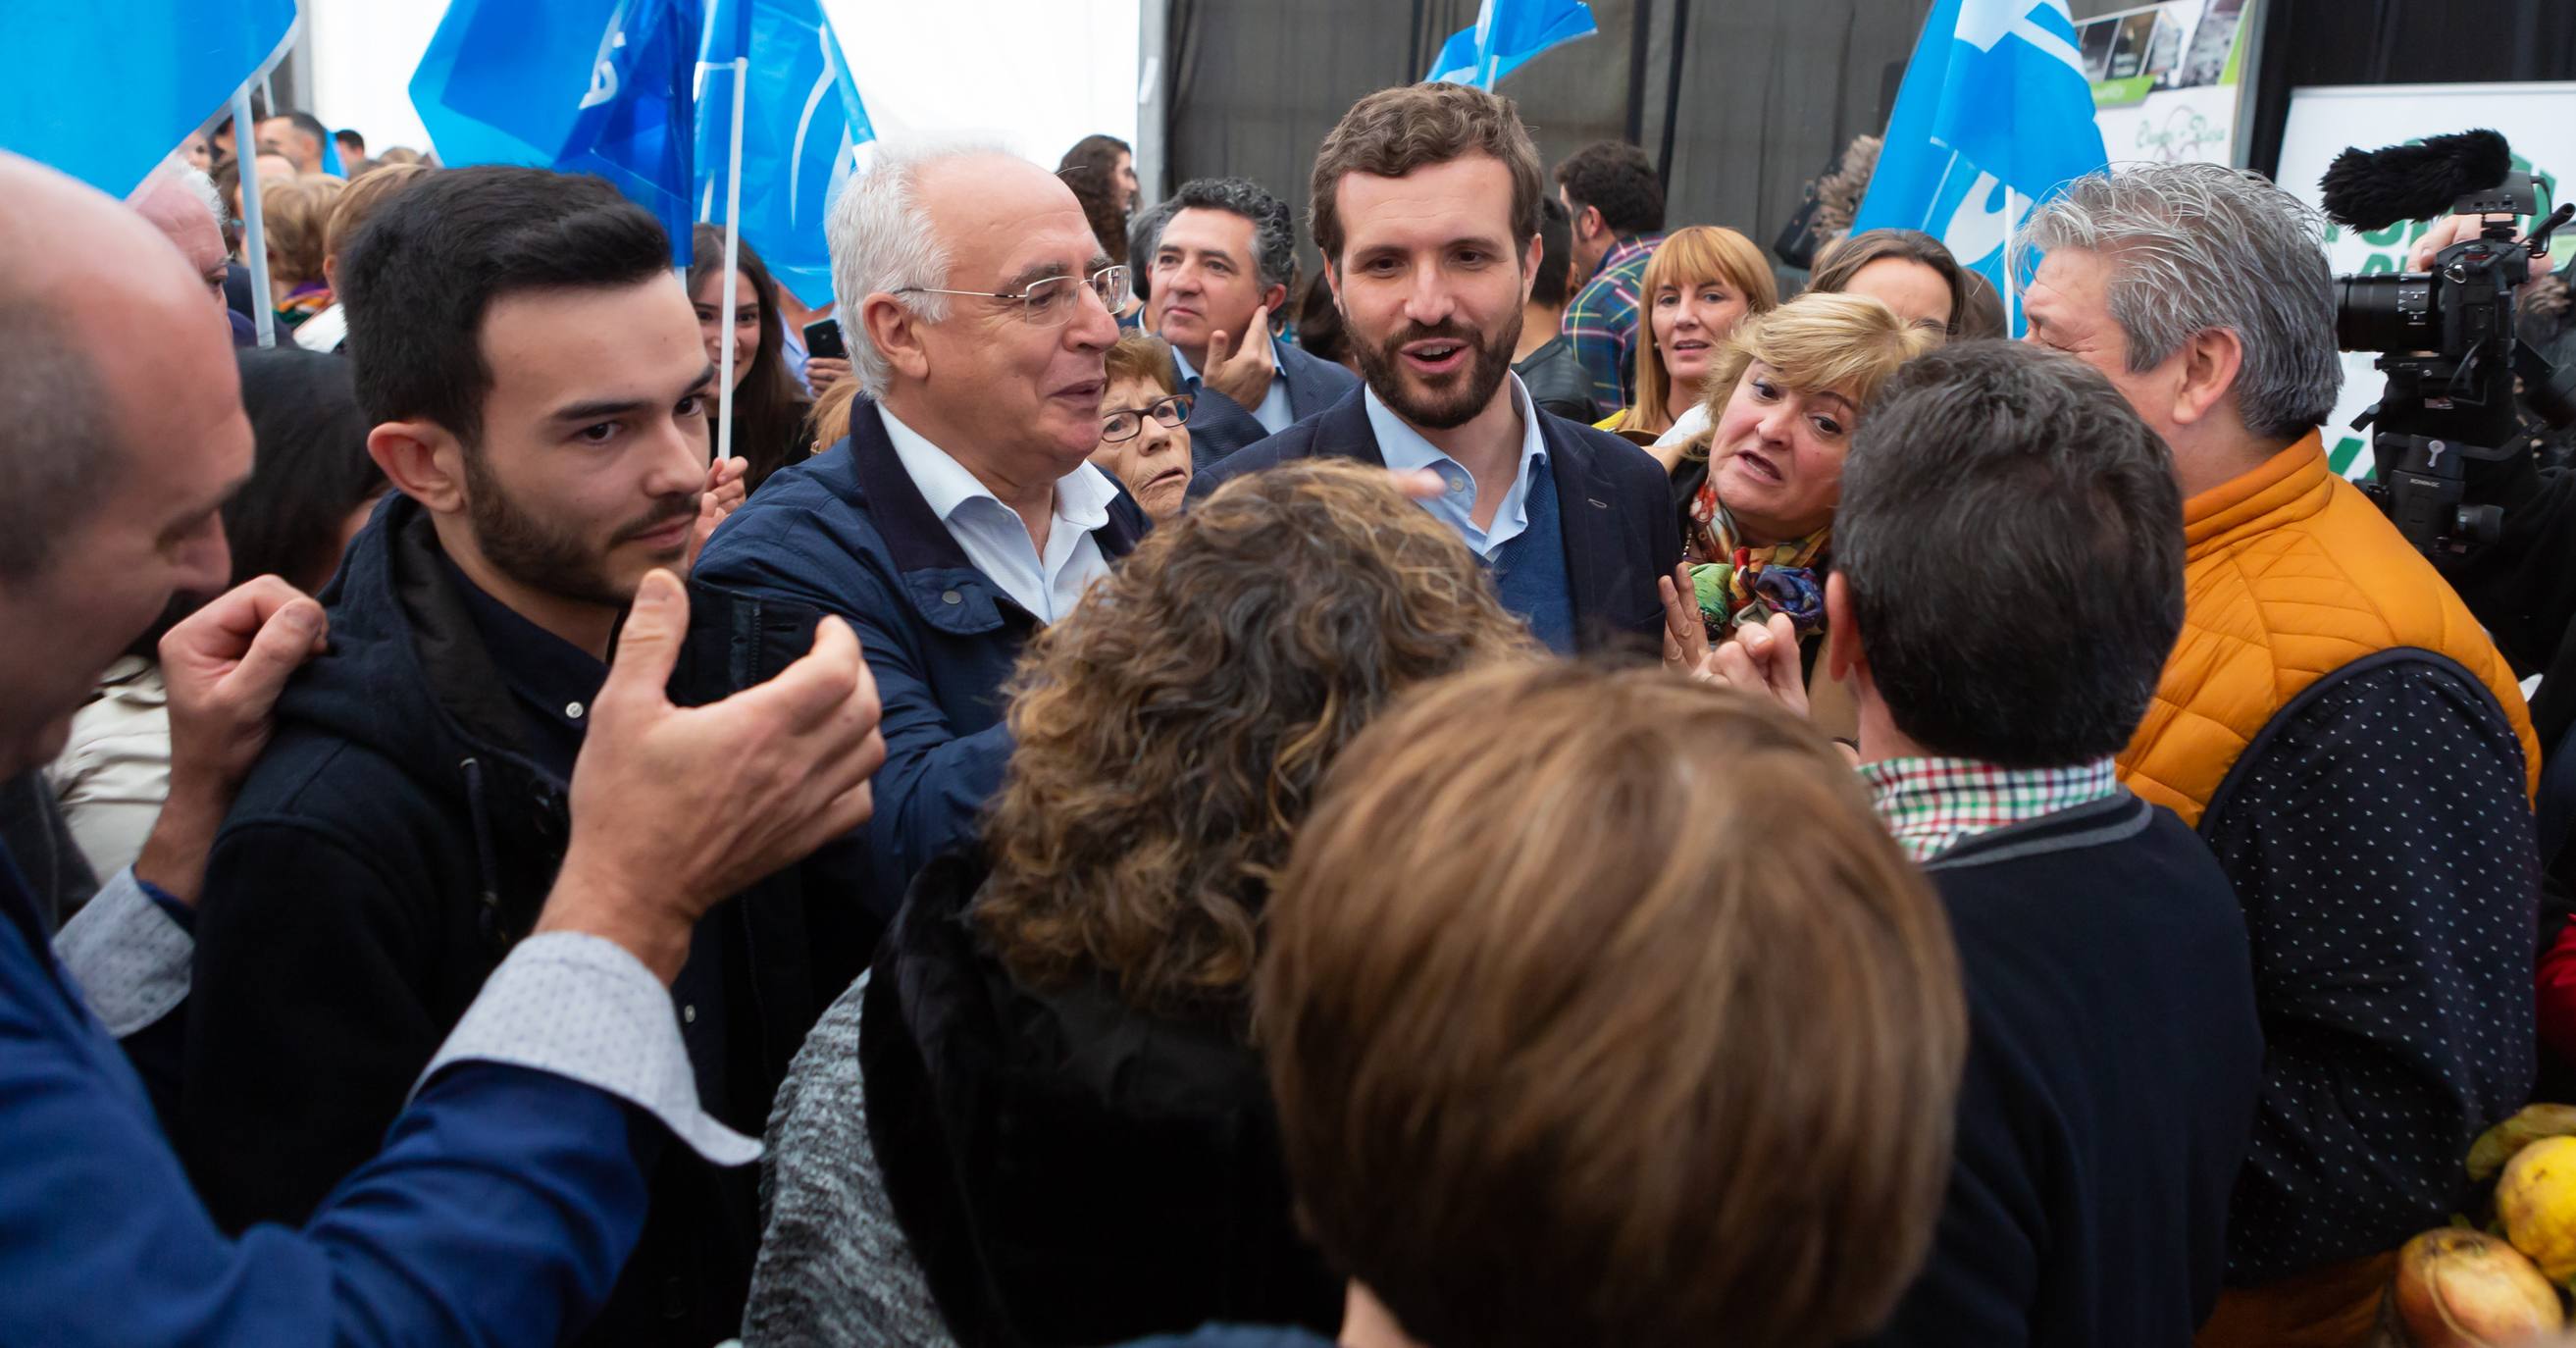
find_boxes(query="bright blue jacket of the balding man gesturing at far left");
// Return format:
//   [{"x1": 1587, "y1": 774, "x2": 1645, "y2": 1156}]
[{"x1": 0, "y1": 854, "x2": 667, "y2": 1348}]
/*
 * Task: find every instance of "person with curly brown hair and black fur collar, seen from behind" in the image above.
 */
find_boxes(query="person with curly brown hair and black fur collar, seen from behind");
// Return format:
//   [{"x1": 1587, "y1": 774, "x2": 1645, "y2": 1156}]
[{"x1": 745, "y1": 461, "x2": 1535, "y2": 1345}]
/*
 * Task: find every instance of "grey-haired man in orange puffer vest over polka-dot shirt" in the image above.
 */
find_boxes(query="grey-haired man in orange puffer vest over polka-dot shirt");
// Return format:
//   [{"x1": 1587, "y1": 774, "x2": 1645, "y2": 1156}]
[{"x1": 1999, "y1": 165, "x2": 2540, "y2": 1348}]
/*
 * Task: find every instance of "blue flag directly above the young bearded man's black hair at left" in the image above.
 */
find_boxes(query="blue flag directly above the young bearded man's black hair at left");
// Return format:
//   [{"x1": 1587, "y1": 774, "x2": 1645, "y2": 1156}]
[{"x1": 412, "y1": 0, "x2": 706, "y2": 263}]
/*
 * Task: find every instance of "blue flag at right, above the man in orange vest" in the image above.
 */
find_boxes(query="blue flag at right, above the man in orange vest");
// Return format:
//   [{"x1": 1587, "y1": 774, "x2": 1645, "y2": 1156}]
[{"x1": 1852, "y1": 0, "x2": 2110, "y2": 333}]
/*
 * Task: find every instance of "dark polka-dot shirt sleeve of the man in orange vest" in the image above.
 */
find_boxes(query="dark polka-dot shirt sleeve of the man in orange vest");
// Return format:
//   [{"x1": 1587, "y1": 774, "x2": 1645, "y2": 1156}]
[{"x1": 2202, "y1": 652, "x2": 2540, "y2": 1283}]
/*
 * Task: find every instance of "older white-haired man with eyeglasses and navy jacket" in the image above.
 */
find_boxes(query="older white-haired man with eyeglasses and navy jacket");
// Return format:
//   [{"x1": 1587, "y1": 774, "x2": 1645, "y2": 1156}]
[{"x1": 696, "y1": 141, "x2": 1149, "y2": 912}]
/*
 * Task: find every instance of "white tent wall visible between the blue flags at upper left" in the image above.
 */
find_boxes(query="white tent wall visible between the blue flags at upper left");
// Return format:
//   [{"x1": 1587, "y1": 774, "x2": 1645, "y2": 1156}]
[{"x1": 304, "y1": 0, "x2": 1139, "y2": 168}]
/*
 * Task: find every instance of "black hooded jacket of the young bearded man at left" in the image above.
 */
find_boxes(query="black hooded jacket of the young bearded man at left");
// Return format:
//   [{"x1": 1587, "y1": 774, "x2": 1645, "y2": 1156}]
[{"x1": 178, "y1": 494, "x2": 876, "y2": 1345}]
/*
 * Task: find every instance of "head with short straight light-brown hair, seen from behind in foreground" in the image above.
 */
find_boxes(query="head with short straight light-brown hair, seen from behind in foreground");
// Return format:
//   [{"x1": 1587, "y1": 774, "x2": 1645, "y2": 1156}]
[{"x1": 1193, "y1": 665, "x2": 1968, "y2": 1348}]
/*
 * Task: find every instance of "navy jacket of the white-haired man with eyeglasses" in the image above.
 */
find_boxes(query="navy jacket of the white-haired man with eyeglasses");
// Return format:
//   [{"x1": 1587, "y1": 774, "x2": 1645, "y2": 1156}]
[{"x1": 696, "y1": 399, "x2": 1149, "y2": 915}]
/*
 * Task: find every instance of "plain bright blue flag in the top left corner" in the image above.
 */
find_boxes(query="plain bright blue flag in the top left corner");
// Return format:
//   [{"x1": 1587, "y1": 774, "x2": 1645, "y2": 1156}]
[{"x1": 0, "y1": 0, "x2": 296, "y2": 196}]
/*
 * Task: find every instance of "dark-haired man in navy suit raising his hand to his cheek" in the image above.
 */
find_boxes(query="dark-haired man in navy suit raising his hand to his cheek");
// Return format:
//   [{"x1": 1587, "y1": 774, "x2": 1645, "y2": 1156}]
[{"x1": 1141, "y1": 178, "x2": 1361, "y2": 469}]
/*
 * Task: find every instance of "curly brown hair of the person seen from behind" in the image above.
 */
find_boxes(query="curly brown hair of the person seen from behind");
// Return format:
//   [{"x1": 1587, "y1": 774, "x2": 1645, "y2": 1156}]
[{"x1": 971, "y1": 459, "x2": 1535, "y2": 1018}]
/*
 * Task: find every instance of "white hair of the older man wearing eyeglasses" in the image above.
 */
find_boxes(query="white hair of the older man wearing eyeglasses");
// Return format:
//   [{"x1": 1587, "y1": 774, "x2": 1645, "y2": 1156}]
[{"x1": 822, "y1": 136, "x2": 1015, "y2": 397}]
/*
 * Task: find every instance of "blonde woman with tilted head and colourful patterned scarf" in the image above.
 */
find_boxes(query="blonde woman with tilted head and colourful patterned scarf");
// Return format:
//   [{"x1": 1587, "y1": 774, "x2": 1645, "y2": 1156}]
[{"x1": 1654, "y1": 293, "x2": 1942, "y2": 662}]
